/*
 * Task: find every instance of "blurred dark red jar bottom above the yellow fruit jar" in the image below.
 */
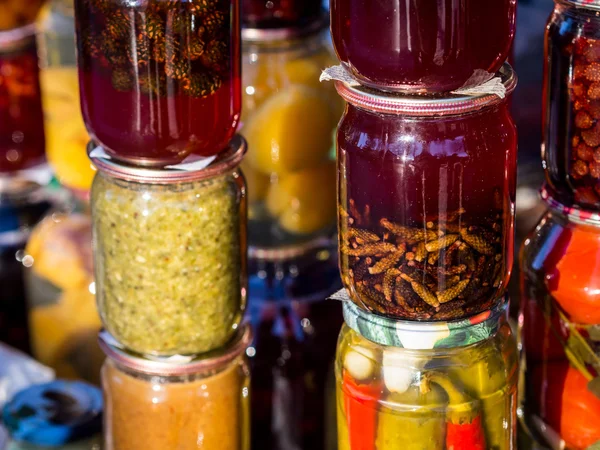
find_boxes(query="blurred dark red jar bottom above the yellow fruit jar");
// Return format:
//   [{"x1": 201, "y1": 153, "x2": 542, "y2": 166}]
[{"x1": 242, "y1": 0, "x2": 323, "y2": 29}]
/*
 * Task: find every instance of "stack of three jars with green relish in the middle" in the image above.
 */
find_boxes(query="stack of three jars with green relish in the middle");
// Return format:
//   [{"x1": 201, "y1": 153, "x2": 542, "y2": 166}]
[{"x1": 75, "y1": 0, "x2": 252, "y2": 450}]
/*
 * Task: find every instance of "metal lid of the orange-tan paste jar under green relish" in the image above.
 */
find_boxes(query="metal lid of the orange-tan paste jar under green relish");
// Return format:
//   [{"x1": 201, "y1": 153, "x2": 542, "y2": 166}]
[{"x1": 98, "y1": 323, "x2": 252, "y2": 377}]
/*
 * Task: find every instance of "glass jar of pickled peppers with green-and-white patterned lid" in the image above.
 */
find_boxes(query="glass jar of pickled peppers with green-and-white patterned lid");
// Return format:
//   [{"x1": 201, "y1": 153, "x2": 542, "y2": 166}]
[{"x1": 336, "y1": 303, "x2": 518, "y2": 450}]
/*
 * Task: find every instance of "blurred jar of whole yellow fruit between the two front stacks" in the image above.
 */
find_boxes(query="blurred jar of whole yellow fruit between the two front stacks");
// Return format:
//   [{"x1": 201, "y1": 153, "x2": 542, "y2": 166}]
[{"x1": 241, "y1": 21, "x2": 342, "y2": 249}]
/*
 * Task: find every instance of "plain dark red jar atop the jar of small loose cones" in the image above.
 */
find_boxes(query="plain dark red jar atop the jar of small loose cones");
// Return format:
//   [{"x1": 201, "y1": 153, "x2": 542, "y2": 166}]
[{"x1": 331, "y1": 0, "x2": 516, "y2": 93}]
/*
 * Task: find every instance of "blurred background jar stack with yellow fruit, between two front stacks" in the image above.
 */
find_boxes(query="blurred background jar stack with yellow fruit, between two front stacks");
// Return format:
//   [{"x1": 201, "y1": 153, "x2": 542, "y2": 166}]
[{"x1": 241, "y1": 0, "x2": 342, "y2": 450}]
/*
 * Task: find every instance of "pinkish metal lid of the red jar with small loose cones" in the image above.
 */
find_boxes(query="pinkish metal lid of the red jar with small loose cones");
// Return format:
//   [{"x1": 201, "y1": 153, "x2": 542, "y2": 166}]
[{"x1": 335, "y1": 63, "x2": 517, "y2": 117}]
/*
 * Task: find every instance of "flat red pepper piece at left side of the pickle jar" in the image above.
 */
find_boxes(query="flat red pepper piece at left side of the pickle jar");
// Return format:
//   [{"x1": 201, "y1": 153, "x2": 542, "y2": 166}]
[{"x1": 343, "y1": 371, "x2": 381, "y2": 450}]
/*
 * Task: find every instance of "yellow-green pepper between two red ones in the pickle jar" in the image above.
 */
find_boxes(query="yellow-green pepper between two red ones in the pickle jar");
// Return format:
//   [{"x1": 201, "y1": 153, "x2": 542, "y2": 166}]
[{"x1": 376, "y1": 385, "x2": 447, "y2": 450}]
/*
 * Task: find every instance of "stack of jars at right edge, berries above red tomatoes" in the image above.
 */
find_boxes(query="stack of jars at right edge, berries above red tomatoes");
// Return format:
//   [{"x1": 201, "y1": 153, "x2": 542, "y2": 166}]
[{"x1": 519, "y1": 0, "x2": 600, "y2": 449}]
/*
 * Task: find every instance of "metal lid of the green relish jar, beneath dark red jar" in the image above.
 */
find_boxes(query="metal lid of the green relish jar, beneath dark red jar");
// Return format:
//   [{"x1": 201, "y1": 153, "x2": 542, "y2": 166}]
[{"x1": 87, "y1": 134, "x2": 247, "y2": 184}]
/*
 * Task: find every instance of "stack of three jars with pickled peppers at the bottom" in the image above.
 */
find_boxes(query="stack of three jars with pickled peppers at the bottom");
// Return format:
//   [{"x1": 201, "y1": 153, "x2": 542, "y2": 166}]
[{"x1": 331, "y1": 0, "x2": 517, "y2": 450}]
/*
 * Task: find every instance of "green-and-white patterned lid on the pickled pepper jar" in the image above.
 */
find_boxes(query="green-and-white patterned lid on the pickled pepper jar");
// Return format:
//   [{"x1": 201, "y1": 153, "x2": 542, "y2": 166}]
[{"x1": 344, "y1": 297, "x2": 509, "y2": 350}]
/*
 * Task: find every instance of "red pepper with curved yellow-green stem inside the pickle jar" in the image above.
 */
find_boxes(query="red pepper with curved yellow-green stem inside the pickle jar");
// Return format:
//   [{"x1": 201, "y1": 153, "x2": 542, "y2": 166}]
[{"x1": 423, "y1": 373, "x2": 486, "y2": 450}]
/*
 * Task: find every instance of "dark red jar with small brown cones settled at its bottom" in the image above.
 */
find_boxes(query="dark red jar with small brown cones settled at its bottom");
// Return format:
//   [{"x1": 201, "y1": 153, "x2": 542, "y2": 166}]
[{"x1": 336, "y1": 65, "x2": 517, "y2": 320}]
